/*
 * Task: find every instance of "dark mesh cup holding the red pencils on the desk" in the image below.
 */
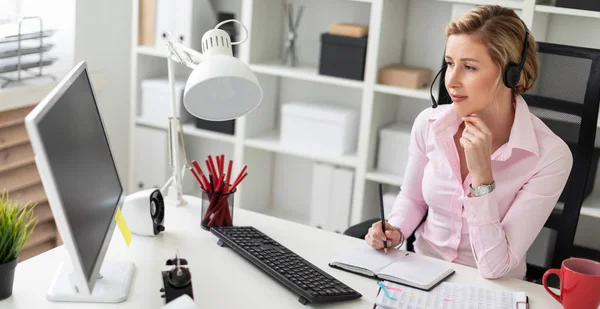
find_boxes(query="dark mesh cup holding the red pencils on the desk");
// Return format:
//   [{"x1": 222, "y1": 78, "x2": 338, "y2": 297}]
[{"x1": 201, "y1": 189, "x2": 237, "y2": 230}]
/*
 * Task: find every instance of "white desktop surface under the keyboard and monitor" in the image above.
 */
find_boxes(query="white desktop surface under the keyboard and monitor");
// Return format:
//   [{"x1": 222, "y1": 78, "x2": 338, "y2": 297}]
[{"x1": 0, "y1": 199, "x2": 561, "y2": 309}]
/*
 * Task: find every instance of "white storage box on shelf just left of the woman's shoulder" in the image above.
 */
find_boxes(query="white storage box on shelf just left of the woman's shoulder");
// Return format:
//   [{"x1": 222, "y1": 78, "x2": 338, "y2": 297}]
[{"x1": 377, "y1": 123, "x2": 411, "y2": 176}]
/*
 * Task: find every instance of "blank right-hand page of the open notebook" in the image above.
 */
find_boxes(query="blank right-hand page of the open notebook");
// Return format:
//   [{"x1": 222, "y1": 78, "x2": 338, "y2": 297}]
[{"x1": 379, "y1": 254, "x2": 452, "y2": 286}]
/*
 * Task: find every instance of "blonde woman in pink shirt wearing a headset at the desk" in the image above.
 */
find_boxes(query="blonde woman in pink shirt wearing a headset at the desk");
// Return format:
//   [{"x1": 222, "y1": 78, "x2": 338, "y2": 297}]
[{"x1": 365, "y1": 6, "x2": 573, "y2": 279}]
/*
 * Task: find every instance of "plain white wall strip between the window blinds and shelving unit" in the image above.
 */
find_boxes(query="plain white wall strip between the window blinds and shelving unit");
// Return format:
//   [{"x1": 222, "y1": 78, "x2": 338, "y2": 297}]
[{"x1": 74, "y1": 0, "x2": 132, "y2": 184}]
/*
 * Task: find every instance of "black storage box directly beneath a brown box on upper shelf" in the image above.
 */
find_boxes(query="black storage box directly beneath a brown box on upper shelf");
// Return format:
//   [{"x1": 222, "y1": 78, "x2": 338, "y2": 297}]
[{"x1": 319, "y1": 33, "x2": 367, "y2": 80}]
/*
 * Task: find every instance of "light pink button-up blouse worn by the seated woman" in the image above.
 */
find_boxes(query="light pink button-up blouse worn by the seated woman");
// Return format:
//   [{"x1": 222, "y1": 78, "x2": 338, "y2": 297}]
[{"x1": 389, "y1": 96, "x2": 573, "y2": 279}]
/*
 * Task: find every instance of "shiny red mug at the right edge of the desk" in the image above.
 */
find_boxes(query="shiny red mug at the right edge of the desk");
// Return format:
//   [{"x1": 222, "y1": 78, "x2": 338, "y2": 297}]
[{"x1": 542, "y1": 258, "x2": 600, "y2": 309}]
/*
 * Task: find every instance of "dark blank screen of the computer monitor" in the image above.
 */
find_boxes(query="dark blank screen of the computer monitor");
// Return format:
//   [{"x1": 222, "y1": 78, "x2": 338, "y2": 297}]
[{"x1": 38, "y1": 70, "x2": 123, "y2": 282}]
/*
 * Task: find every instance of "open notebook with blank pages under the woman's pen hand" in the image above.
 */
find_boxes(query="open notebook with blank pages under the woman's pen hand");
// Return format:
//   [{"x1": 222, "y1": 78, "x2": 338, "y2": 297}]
[{"x1": 329, "y1": 246, "x2": 454, "y2": 290}]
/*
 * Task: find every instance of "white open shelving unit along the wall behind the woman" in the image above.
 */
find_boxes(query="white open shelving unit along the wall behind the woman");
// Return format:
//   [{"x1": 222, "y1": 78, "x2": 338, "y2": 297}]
[{"x1": 131, "y1": 0, "x2": 600, "y2": 239}]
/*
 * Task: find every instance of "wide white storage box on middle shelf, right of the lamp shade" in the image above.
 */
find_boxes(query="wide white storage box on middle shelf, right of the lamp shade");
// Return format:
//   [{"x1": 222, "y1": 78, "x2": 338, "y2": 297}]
[{"x1": 280, "y1": 102, "x2": 359, "y2": 155}]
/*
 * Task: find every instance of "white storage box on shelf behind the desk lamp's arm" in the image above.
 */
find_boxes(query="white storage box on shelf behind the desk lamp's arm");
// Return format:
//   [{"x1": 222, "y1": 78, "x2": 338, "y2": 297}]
[{"x1": 139, "y1": 78, "x2": 194, "y2": 125}]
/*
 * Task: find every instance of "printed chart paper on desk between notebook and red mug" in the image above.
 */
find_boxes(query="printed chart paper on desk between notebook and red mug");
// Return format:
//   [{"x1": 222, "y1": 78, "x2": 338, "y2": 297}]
[{"x1": 375, "y1": 281, "x2": 526, "y2": 309}]
